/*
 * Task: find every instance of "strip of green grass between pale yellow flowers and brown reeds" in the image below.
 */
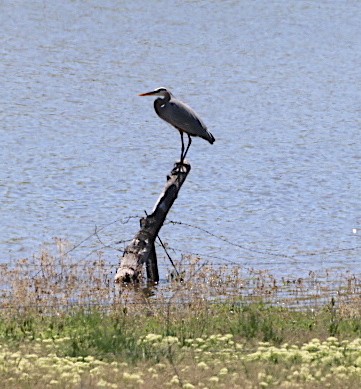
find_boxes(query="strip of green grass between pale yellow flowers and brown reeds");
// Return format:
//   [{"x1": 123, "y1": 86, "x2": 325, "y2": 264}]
[{"x1": 0, "y1": 301, "x2": 361, "y2": 361}]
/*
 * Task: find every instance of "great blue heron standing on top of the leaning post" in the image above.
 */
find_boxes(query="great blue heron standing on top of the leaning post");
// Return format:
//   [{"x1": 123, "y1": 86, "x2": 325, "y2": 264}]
[{"x1": 139, "y1": 88, "x2": 215, "y2": 164}]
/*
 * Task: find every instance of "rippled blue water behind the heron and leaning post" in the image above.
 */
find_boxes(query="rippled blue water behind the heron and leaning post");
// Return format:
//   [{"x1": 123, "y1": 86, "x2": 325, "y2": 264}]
[{"x1": 0, "y1": 0, "x2": 361, "y2": 276}]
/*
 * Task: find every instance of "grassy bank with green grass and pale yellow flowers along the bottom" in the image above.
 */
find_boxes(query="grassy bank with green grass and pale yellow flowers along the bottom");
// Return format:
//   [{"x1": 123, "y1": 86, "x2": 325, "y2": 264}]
[{"x1": 0, "y1": 302, "x2": 361, "y2": 388}]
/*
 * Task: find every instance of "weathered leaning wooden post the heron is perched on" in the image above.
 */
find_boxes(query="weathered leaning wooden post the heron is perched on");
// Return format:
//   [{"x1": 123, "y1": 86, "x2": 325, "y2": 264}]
[{"x1": 115, "y1": 162, "x2": 191, "y2": 283}]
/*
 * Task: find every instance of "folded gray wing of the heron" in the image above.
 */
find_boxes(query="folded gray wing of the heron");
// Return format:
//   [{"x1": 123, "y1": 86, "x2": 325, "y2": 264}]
[{"x1": 157, "y1": 99, "x2": 208, "y2": 137}]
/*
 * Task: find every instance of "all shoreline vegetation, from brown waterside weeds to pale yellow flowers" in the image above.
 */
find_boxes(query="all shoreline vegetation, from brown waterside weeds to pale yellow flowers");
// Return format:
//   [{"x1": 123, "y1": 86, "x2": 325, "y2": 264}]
[{"x1": 0, "y1": 250, "x2": 361, "y2": 389}]
